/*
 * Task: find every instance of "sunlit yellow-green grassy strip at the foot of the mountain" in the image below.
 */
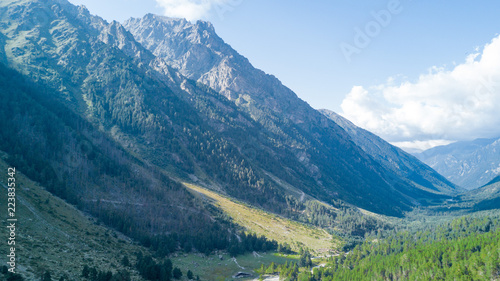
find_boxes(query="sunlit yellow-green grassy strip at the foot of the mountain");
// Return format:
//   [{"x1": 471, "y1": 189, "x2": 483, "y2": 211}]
[{"x1": 184, "y1": 183, "x2": 334, "y2": 252}]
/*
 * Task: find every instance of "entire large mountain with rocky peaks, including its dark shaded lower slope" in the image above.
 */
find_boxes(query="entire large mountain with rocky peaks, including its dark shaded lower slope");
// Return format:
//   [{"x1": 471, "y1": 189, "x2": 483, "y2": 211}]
[{"x1": 0, "y1": 0, "x2": 458, "y2": 226}]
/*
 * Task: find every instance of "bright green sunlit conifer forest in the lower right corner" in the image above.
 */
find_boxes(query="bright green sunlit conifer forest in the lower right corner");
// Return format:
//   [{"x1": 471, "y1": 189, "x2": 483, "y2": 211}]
[{"x1": 254, "y1": 213, "x2": 500, "y2": 280}]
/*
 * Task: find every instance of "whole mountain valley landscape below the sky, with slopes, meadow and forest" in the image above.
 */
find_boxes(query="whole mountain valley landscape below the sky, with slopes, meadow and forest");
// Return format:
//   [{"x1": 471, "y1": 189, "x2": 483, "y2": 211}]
[{"x1": 0, "y1": 0, "x2": 500, "y2": 281}]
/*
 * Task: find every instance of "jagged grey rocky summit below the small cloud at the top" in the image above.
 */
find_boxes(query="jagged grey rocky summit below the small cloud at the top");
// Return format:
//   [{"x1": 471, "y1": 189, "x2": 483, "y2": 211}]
[{"x1": 124, "y1": 15, "x2": 311, "y2": 115}]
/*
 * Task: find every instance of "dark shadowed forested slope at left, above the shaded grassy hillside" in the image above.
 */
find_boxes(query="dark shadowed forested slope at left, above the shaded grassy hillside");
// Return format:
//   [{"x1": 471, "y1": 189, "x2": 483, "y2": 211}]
[{"x1": 0, "y1": 57, "x2": 227, "y2": 247}]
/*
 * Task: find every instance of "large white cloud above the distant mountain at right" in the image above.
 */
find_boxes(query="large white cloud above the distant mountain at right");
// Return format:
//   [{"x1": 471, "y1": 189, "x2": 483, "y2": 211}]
[{"x1": 342, "y1": 36, "x2": 500, "y2": 150}]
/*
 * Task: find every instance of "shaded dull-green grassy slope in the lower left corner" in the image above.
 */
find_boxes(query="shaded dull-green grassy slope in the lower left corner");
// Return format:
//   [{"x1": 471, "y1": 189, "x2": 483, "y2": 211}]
[{"x1": 0, "y1": 153, "x2": 147, "y2": 280}]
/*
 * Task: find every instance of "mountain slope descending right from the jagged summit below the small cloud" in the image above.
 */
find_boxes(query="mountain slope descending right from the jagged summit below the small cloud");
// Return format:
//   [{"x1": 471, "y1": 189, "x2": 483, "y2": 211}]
[{"x1": 124, "y1": 14, "x2": 458, "y2": 212}]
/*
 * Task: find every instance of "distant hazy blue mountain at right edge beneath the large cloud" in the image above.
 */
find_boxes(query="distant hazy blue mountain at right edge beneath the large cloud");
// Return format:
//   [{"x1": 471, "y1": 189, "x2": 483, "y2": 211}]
[{"x1": 415, "y1": 138, "x2": 500, "y2": 189}]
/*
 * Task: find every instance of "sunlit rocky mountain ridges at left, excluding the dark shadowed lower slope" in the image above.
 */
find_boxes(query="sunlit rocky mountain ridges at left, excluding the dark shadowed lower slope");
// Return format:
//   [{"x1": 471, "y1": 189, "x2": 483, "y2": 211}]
[{"x1": 0, "y1": 1, "x2": 460, "y2": 219}]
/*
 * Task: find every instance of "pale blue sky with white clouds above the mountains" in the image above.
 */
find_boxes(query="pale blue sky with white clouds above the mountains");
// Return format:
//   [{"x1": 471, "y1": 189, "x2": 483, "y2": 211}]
[{"x1": 71, "y1": 0, "x2": 500, "y2": 151}]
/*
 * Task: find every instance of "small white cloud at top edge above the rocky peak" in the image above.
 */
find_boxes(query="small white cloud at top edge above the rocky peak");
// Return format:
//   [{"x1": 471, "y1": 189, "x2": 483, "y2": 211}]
[{"x1": 156, "y1": 0, "x2": 242, "y2": 20}]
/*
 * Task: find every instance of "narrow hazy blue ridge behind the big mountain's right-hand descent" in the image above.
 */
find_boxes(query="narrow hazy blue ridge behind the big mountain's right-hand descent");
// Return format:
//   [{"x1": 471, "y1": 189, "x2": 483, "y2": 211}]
[{"x1": 319, "y1": 109, "x2": 457, "y2": 194}]
